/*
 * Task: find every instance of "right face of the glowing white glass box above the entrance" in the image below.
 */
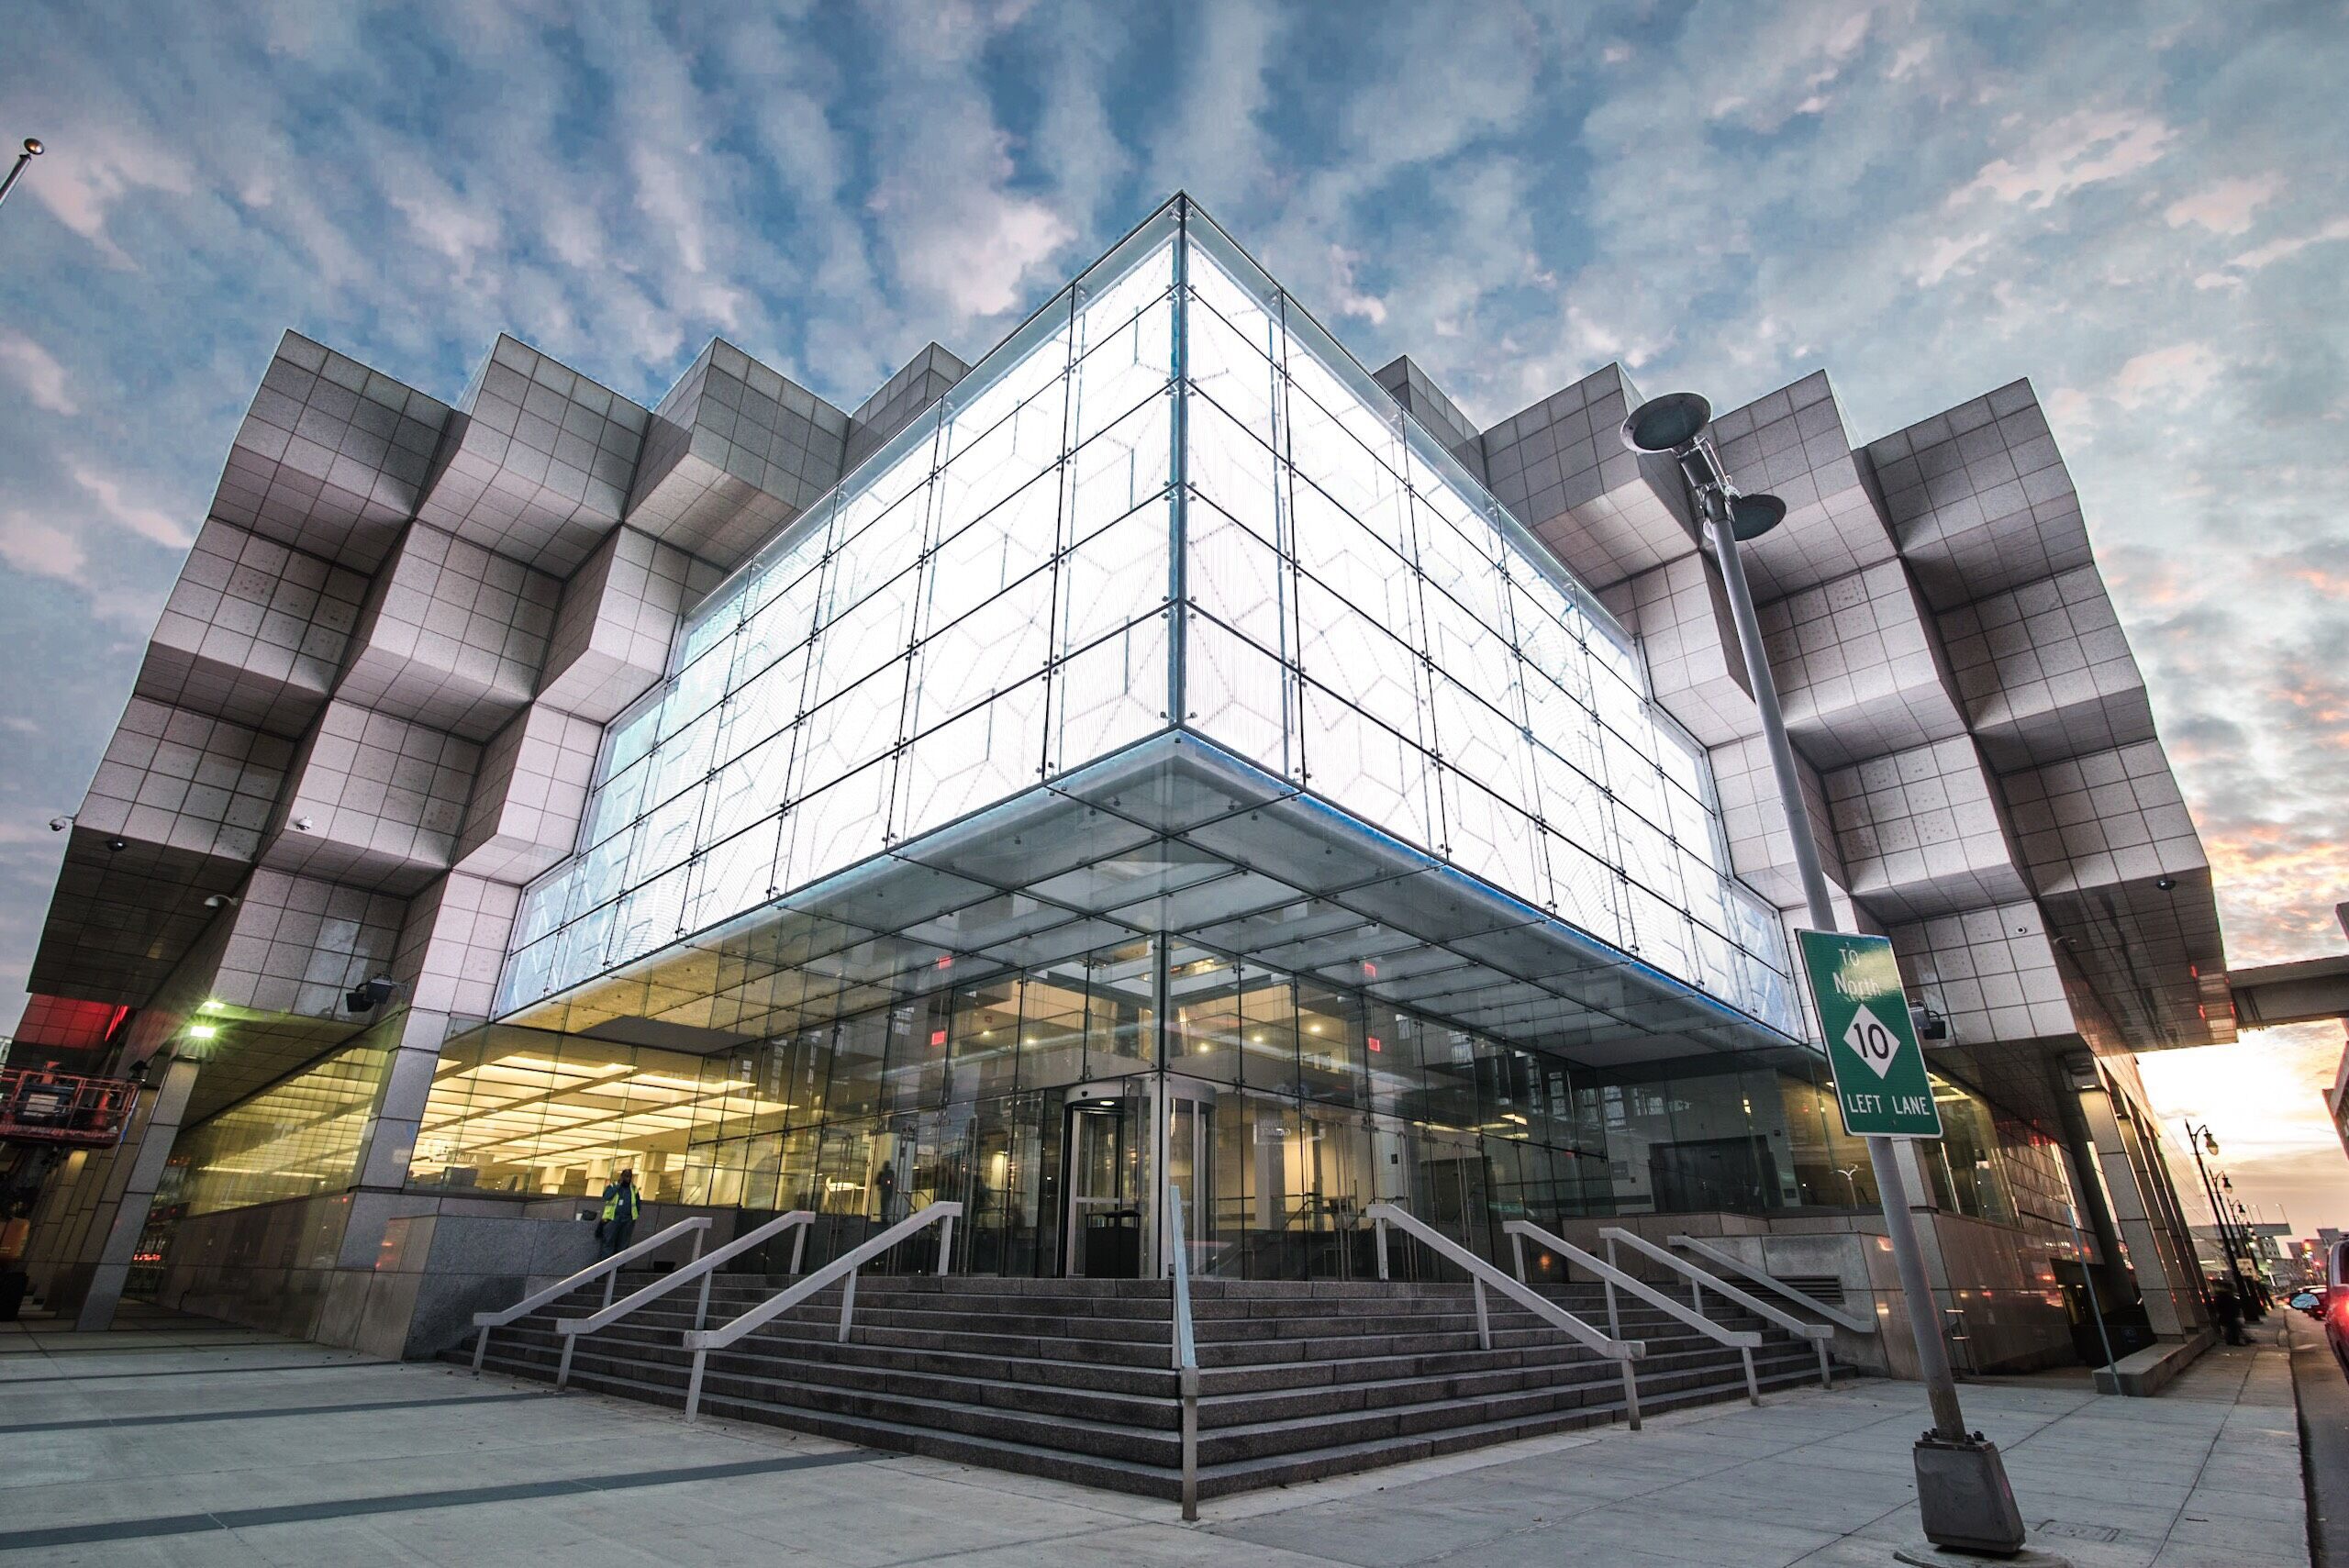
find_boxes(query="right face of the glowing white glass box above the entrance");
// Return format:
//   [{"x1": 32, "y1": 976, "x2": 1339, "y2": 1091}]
[{"x1": 1179, "y1": 211, "x2": 1797, "y2": 1035}]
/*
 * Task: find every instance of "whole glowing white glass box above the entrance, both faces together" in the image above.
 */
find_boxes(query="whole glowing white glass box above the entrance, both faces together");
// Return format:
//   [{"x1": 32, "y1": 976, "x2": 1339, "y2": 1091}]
[{"x1": 500, "y1": 209, "x2": 1795, "y2": 1033}]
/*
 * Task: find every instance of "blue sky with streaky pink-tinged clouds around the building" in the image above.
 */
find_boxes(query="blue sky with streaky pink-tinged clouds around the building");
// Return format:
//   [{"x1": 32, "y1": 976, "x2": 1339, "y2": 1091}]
[{"x1": 0, "y1": 0, "x2": 2349, "y2": 1230}]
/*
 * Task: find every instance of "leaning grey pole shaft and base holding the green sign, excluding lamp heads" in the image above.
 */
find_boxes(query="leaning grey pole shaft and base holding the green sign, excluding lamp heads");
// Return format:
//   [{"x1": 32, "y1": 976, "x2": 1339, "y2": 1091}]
[{"x1": 1700, "y1": 502, "x2": 2022, "y2": 1556}]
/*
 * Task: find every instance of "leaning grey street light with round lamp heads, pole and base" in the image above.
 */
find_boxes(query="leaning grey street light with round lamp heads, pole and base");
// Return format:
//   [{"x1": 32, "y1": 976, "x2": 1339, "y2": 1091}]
[{"x1": 1623, "y1": 392, "x2": 2022, "y2": 1556}]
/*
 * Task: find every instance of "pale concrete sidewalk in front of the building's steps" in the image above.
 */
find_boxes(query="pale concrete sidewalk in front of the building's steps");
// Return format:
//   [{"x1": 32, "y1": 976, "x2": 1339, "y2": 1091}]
[{"x1": 0, "y1": 1319, "x2": 2309, "y2": 1568}]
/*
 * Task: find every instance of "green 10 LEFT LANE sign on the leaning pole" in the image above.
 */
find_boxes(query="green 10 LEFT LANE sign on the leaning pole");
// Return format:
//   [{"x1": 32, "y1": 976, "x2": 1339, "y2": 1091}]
[{"x1": 1795, "y1": 932, "x2": 1941, "y2": 1139}]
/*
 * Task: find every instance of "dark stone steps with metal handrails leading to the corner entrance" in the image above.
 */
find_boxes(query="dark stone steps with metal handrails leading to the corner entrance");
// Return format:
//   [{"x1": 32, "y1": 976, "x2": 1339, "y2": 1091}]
[{"x1": 449, "y1": 1274, "x2": 1818, "y2": 1497}]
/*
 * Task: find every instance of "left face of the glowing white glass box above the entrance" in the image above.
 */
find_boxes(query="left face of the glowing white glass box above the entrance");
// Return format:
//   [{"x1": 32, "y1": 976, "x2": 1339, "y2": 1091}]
[{"x1": 498, "y1": 211, "x2": 1177, "y2": 1014}]
